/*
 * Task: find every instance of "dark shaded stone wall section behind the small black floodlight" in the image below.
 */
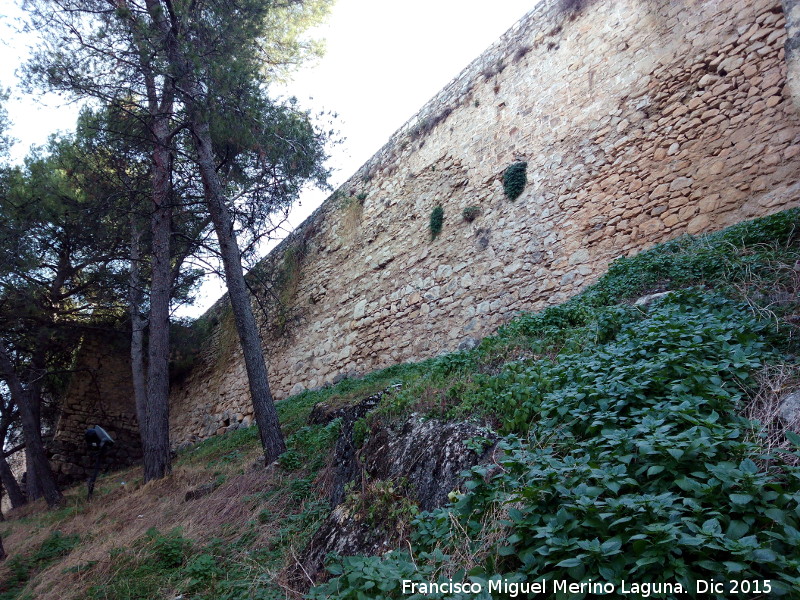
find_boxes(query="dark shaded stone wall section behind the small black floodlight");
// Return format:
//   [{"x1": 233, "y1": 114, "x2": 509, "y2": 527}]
[{"x1": 48, "y1": 332, "x2": 142, "y2": 483}]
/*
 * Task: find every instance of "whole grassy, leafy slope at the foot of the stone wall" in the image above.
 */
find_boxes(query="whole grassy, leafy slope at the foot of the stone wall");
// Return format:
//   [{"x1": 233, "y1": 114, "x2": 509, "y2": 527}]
[{"x1": 0, "y1": 210, "x2": 800, "y2": 600}]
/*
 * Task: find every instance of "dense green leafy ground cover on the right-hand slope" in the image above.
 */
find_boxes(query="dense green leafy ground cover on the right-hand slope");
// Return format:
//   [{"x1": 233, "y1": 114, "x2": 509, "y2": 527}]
[{"x1": 308, "y1": 210, "x2": 800, "y2": 599}]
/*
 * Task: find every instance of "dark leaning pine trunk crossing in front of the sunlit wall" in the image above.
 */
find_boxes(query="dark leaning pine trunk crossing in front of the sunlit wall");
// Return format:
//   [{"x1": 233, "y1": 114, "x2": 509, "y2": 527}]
[{"x1": 191, "y1": 117, "x2": 286, "y2": 464}]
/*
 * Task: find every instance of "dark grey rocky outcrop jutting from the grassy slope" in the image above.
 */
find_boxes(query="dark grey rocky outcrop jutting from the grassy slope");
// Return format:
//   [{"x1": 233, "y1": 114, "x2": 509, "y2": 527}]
[{"x1": 291, "y1": 399, "x2": 493, "y2": 589}]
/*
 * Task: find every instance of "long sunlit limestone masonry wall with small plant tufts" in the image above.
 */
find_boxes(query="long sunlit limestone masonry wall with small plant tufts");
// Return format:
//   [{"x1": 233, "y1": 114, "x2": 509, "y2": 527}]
[{"x1": 73, "y1": 0, "x2": 800, "y2": 444}]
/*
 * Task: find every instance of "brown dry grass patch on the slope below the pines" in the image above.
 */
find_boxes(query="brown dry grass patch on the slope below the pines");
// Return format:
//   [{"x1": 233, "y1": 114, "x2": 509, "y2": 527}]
[{"x1": 0, "y1": 434, "x2": 324, "y2": 600}]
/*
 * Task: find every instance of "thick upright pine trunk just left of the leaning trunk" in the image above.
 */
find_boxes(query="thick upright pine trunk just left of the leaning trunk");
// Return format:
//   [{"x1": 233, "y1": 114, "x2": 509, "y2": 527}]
[{"x1": 139, "y1": 114, "x2": 172, "y2": 482}]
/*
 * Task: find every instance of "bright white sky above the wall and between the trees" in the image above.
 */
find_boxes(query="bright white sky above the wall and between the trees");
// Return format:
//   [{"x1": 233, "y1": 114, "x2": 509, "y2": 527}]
[{"x1": 0, "y1": 0, "x2": 539, "y2": 316}]
